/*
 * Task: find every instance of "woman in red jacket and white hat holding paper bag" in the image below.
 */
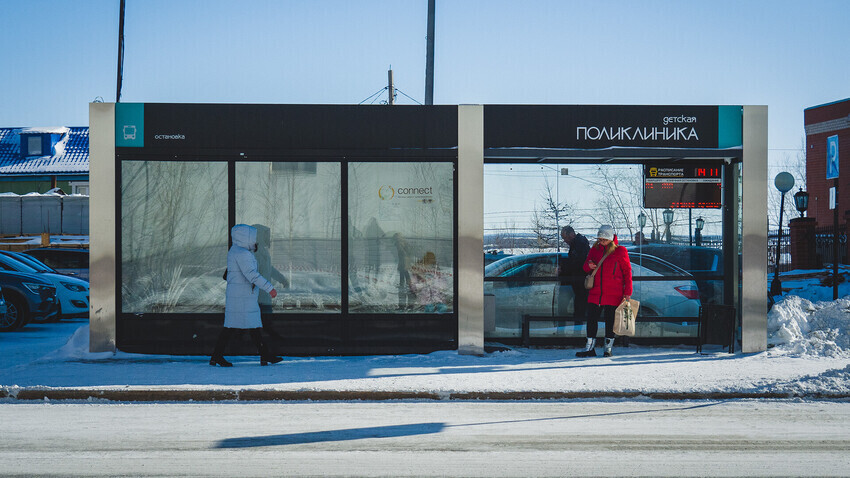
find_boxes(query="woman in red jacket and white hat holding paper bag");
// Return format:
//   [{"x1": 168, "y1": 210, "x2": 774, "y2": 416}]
[{"x1": 576, "y1": 225, "x2": 632, "y2": 357}]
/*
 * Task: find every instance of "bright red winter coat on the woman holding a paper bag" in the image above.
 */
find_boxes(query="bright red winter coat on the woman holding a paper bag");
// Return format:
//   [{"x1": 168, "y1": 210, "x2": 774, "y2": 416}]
[{"x1": 584, "y1": 237, "x2": 632, "y2": 307}]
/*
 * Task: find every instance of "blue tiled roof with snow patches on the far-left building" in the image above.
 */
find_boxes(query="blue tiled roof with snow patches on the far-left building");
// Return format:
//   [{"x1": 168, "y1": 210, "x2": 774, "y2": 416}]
[{"x1": 0, "y1": 126, "x2": 89, "y2": 176}]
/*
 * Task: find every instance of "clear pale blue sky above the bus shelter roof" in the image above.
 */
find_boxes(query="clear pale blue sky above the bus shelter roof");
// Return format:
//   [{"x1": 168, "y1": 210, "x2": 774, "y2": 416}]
[{"x1": 0, "y1": 0, "x2": 850, "y2": 232}]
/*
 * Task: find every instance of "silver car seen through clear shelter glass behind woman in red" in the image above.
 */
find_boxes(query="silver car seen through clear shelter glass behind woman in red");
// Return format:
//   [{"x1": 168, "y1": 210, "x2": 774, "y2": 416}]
[{"x1": 484, "y1": 252, "x2": 700, "y2": 338}]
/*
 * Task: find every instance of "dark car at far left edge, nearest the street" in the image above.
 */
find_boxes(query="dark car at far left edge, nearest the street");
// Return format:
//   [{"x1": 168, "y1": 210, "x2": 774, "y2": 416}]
[{"x1": 0, "y1": 271, "x2": 59, "y2": 332}]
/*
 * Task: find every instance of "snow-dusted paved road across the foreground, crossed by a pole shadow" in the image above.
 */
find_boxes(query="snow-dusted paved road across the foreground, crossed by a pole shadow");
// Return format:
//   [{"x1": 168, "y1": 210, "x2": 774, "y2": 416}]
[{"x1": 0, "y1": 401, "x2": 850, "y2": 477}]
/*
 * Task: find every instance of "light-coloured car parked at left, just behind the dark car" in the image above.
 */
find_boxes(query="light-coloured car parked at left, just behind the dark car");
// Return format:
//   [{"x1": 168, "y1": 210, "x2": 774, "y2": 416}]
[{"x1": 0, "y1": 251, "x2": 89, "y2": 319}]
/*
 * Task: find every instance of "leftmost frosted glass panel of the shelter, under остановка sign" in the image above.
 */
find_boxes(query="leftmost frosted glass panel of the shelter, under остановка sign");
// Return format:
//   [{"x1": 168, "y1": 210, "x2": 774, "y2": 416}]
[{"x1": 121, "y1": 161, "x2": 227, "y2": 314}]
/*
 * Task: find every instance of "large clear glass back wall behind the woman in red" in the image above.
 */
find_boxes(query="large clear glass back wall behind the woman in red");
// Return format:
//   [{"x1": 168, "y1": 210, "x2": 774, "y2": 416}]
[{"x1": 484, "y1": 164, "x2": 712, "y2": 338}]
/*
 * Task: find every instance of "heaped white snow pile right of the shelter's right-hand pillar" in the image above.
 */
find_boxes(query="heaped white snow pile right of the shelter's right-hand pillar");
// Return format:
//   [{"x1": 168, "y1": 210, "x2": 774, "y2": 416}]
[{"x1": 767, "y1": 295, "x2": 850, "y2": 357}]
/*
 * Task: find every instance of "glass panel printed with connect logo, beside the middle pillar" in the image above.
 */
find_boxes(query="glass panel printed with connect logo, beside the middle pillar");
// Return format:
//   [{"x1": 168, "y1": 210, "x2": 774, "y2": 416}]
[{"x1": 348, "y1": 163, "x2": 454, "y2": 313}]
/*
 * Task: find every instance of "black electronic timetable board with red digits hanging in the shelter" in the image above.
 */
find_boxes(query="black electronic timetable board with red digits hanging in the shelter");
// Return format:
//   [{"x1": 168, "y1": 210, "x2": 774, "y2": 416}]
[{"x1": 643, "y1": 164, "x2": 723, "y2": 209}]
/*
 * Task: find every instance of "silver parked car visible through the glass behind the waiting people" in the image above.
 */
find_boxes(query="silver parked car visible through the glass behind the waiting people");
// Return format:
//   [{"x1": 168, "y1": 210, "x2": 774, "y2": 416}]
[{"x1": 484, "y1": 252, "x2": 700, "y2": 335}]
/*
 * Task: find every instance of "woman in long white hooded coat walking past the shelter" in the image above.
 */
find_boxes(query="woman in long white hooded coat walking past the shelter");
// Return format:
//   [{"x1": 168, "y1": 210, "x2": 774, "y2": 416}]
[{"x1": 210, "y1": 224, "x2": 283, "y2": 367}]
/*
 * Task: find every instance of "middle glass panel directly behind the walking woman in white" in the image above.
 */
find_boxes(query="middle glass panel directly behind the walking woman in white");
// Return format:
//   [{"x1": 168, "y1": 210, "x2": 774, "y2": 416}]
[{"x1": 236, "y1": 162, "x2": 342, "y2": 313}]
